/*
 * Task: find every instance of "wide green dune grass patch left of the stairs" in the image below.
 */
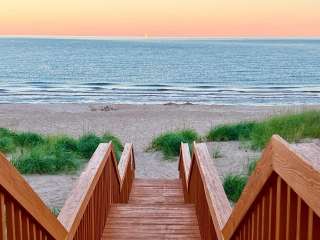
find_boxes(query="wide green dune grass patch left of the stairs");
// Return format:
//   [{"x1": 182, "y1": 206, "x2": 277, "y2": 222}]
[{"x1": 0, "y1": 128, "x2": 123, "y2": 174}]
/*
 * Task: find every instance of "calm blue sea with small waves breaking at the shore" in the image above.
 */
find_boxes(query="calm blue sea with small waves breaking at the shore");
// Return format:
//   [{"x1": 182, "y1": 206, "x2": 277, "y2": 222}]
[{"x1": 0, "y1": 38, "x2": 320, "y2": 105}]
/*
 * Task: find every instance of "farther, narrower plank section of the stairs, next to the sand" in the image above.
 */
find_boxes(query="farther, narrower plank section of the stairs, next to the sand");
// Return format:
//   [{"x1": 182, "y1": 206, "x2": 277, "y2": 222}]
[{"x1": 129, "y1": 179, "x2": 184, "y2": 204}]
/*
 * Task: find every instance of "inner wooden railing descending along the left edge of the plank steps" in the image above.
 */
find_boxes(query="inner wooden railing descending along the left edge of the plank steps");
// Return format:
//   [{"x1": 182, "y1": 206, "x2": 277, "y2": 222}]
[{"x1": 58, "y1": 143, "x2": 135, "y2": 240}]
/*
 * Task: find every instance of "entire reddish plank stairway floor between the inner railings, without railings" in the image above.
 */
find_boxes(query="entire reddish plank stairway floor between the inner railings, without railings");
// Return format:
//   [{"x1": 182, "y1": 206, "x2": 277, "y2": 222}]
[{"x1": 102, "y1": 179, "x2": 201, "y2": 239}]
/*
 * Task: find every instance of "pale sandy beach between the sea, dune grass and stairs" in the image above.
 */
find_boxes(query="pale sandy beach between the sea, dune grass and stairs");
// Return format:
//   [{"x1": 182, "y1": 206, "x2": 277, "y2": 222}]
[{"x1": 0, "y1": 104, "x2": 320, "y2": 208}]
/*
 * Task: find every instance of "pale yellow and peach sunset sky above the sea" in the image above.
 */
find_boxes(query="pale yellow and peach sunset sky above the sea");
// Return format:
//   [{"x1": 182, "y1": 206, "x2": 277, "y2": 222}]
[{"x1": 0, "y1": 0, "x2": 320, "y2": 37}]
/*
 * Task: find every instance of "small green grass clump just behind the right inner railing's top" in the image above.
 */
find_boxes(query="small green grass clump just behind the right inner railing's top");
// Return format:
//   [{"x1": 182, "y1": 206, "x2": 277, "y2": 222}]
[{"x1": 150, "y1": 129, "x2": 200, "y2": 159}]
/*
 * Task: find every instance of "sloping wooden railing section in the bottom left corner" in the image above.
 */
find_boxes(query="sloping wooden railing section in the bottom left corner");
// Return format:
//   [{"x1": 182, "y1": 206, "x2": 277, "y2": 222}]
[{"x1": 0, "y1": 153, "x2": 67, "y2": 240}]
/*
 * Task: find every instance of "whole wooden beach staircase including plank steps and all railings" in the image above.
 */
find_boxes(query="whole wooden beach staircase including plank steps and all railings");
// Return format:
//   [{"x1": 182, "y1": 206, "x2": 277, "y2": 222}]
[{"x1": 0, "y1": 136, "x2": 320, "y2": 240}]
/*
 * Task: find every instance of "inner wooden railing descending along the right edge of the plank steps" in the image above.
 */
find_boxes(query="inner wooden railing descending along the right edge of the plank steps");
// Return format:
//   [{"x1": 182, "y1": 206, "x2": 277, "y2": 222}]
[{"x1": 179, "y1": 143, "x2": 231, "y2": 239}]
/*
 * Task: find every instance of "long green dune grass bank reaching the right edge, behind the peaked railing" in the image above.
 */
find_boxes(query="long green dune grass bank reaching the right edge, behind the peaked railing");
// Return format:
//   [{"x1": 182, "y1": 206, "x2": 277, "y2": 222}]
[{"x1": 207, "y1": 111, "x2": 320, "y2": 150}]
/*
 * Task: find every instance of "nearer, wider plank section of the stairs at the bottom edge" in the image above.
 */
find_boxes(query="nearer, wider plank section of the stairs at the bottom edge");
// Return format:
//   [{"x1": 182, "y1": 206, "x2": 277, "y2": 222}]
[{"x1": 102, "y1": 204, "x2": 200, "y2": 239}]
